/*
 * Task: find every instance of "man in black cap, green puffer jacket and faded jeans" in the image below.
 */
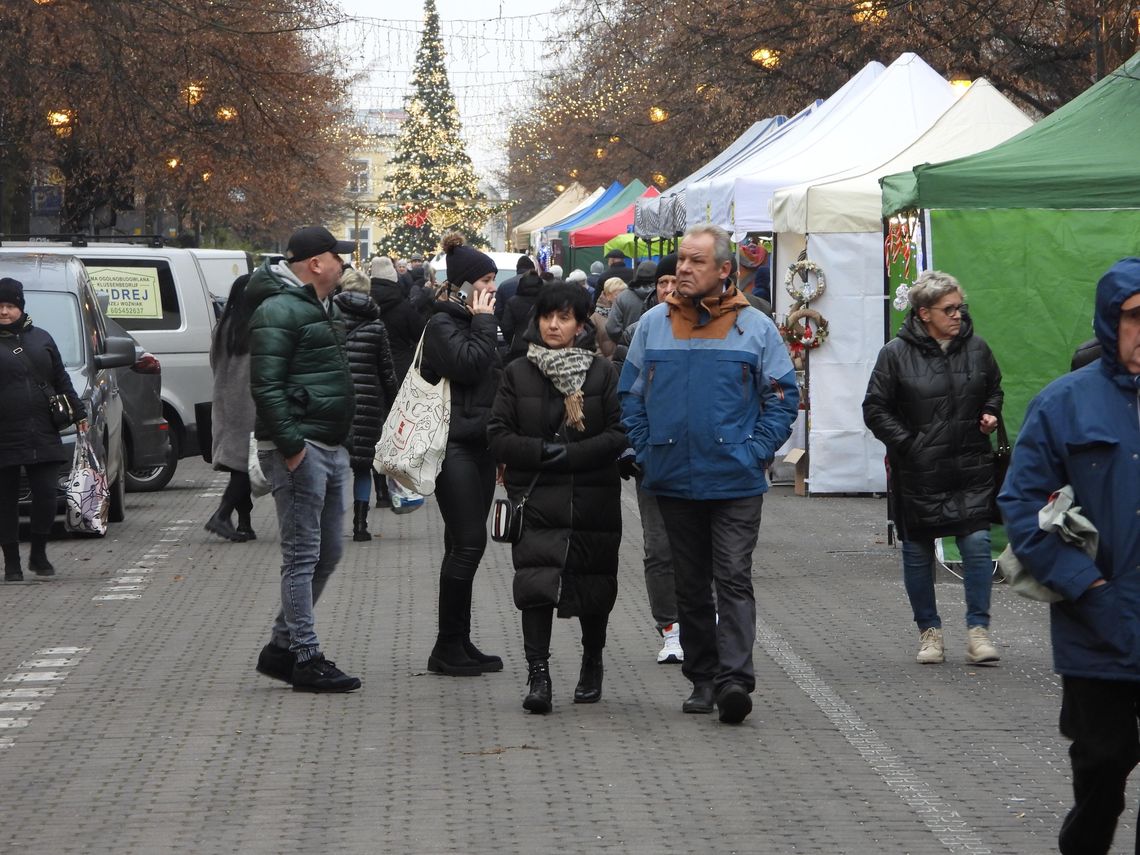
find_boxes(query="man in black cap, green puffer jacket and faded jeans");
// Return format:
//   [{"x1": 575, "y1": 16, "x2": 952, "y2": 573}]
[{"x1": 245, "y1": 226, "x2": 360, "y2": 692}]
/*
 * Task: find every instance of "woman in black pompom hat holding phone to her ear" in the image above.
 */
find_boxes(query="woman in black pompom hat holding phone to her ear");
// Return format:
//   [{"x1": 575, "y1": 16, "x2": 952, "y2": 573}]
[{"x1": 422, "y1": 234, "x2": 503, "y2": 677}]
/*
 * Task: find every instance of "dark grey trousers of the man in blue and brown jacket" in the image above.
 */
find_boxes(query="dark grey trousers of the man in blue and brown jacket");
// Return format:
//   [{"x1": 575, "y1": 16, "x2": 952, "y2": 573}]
[{"x1": 658, "y1": 495, "x2": 764, "y2": 692}]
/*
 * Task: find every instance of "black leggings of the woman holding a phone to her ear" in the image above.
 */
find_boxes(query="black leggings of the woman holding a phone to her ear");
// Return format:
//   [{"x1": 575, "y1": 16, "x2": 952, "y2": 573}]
[{"x1": 435, "y1": 442, "x2": 495, "y2": 581}]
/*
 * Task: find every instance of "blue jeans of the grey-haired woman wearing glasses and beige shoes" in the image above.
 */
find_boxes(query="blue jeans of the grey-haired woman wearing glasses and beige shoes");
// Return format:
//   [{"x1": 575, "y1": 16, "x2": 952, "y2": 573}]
[{"x1": 903, "y1": 529, "x2": 994, "y2": 632}]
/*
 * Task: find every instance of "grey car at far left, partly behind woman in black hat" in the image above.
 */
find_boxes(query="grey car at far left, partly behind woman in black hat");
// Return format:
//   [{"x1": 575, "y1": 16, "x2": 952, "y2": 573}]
[{"x1": 0, "y1": 254, "x2": 135, "y2": 533}]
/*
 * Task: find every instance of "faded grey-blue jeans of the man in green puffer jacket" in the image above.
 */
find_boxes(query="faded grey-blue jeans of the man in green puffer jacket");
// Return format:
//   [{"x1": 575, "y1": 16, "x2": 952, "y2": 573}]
[{"x1": 259, "y1": 442, "x2": 349, "y2": 662}]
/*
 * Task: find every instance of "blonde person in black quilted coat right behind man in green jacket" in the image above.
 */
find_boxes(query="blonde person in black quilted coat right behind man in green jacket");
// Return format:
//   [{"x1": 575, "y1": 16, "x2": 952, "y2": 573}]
[{"x1": 333, "y1": 268, "x2": 400, "y2": 543}]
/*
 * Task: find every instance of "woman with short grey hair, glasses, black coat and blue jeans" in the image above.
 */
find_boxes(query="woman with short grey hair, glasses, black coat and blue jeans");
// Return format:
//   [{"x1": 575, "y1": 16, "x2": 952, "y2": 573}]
[{"x1": 863, "y1": 270, "x2": 1002, "y2": 665}]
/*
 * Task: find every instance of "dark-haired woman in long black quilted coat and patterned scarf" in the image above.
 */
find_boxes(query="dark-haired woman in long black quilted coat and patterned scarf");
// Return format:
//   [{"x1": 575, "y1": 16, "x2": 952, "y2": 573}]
[{"x1": 487, "y1": 284, "x2": 627, "y2": 713}]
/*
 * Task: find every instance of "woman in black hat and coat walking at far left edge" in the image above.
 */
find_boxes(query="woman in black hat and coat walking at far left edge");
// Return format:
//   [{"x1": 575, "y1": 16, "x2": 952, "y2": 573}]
[{"x1": 0, "y1": 277, "x2": 87, "y2": 581}]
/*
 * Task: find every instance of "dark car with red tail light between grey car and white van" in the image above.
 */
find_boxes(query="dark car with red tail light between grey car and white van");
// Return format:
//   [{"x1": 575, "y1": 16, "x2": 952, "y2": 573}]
[{"x1": 99, "y1": 316, "x2": 171, "y2": 492}]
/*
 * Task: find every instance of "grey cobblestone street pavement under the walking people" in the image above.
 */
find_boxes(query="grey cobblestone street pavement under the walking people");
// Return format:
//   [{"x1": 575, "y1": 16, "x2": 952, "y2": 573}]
[{"x1": 0, "y1": 461, "x2": 1135, "y2": 855}]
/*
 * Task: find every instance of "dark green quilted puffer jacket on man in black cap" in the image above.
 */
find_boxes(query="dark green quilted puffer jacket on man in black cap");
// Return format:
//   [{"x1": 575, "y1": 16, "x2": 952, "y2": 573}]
[{"x1": 245, "y1": 262, "x2": 356, "y2": 457}]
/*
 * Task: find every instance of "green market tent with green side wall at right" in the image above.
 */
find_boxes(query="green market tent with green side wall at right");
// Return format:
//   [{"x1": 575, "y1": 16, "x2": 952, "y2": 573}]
[{"x1": 882, "y1": 54, "x2": 1140, "y2": 433}]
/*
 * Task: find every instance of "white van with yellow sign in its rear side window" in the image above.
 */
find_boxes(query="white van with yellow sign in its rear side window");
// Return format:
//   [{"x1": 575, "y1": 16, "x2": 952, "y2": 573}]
[{"x1": 0, "y1": 236, "x2": 216, "y2": 490}]
